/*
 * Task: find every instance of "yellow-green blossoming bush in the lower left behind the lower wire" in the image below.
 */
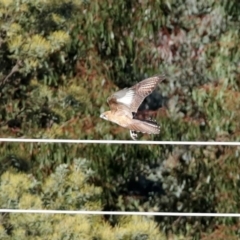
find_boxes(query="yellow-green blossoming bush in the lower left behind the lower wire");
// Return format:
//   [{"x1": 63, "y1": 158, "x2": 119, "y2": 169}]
[{"x1": 0, "y1": 159, "x2": 163, "y2": 239}]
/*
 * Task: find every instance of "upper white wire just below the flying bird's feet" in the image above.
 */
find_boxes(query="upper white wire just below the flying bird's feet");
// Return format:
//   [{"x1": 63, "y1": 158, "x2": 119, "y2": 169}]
[{"x1": 0, "y1": 138, "x2": 240, "y2": 146}]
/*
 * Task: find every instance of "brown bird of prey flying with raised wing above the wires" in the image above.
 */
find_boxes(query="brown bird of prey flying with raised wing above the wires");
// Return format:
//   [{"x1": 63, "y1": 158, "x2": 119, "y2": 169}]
[{"x1": 100, "y1": 76, "x2": 165, "y2": 140}]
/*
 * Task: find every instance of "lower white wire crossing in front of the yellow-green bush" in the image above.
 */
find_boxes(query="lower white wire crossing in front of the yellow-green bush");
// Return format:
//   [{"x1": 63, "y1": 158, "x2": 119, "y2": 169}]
[{"x1": 0, "y1": 209, "x2": 240, "y2": 218}]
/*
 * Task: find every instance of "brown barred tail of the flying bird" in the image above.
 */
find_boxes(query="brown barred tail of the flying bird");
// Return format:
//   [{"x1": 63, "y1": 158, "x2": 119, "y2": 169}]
[{"x1": 128, "y1": 119, "x2": 160, "y2": 134}]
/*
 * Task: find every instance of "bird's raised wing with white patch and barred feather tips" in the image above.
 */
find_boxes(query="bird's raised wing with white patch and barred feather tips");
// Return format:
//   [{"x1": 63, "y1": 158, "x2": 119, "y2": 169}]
[{"x1": 108, "y1": 75, "x2": 165, "y2": 112}]
